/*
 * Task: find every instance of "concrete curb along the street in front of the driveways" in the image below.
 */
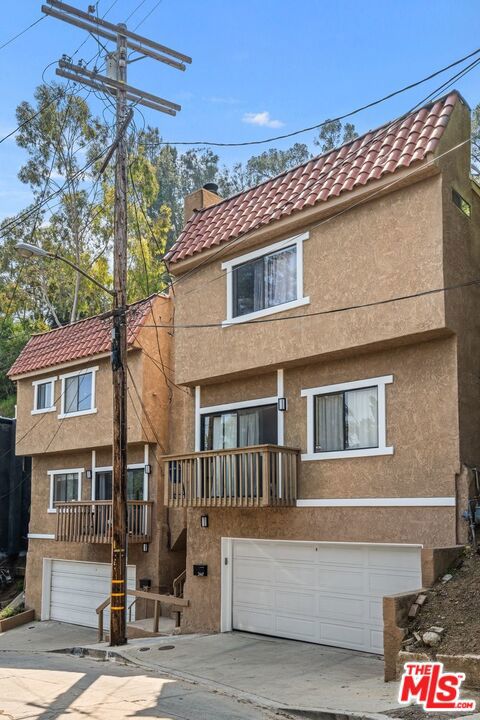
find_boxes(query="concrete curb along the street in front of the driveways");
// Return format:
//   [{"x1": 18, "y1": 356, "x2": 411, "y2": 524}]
[{"x1": 65, "y1": 647, "x2": 392, "y2": 720}]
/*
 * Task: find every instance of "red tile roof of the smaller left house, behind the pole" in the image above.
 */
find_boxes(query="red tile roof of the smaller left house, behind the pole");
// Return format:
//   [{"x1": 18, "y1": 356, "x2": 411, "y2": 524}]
[{"x1": 8, "y1": 295, "x2": 161, "y2": 376}]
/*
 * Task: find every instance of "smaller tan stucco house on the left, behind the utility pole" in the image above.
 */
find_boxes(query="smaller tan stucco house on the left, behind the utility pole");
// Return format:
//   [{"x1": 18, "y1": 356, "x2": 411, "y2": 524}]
[{"x1": 9, "y1": 295, "x2": 185, "y2": 627}]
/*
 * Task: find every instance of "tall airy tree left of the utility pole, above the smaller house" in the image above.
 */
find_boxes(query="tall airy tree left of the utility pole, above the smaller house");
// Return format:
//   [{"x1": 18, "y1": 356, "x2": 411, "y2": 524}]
[{"x1": 12, "y1": 84, "x2": 109, "y2": 325}]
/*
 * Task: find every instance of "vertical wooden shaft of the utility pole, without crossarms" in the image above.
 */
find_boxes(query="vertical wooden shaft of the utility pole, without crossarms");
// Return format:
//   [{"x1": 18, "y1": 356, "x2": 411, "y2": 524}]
[{"x1": 110, "y1": 24, "x2": 127, "y2": 646}]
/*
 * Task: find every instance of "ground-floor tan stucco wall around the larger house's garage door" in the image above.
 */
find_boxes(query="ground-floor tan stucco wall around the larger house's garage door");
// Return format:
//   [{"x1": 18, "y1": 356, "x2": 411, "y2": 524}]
[{"x1": 182, "y1": 507, "x2": 455, "y2": 632}]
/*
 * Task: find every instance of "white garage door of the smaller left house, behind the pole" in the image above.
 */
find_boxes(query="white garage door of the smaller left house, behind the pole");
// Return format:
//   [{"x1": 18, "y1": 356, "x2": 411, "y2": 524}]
[{"x1": 42, "y1": 559, "x2": 136, "y2": 628}]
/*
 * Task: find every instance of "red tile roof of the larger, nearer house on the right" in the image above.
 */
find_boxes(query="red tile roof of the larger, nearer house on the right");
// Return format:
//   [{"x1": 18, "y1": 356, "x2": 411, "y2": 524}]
[{"x1": 167, "y1": 91, "x2": 459, "y2": 264}]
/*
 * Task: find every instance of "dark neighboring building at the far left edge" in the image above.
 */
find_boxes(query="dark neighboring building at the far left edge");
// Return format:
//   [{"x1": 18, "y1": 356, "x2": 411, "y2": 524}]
[{"x1": 0, "y1": 417, "x2": 31, "y2": 558}]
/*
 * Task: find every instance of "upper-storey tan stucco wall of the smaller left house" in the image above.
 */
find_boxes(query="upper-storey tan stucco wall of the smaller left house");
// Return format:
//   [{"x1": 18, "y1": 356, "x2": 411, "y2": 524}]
[{"x1": 17, "y1": 296, "x2": 172, "y2": 455}]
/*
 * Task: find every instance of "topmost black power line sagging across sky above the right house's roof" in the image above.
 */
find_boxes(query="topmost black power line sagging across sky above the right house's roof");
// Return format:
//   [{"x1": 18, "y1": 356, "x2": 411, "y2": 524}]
[{"x1": 141, "y1": 48, "x2": 480, "y2": 147}]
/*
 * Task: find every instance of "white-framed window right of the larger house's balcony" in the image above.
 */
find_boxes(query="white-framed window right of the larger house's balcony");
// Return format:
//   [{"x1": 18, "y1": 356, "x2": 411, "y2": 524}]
[{"x1": 301, "y1": 375, "x2": 393, "y2": 460}]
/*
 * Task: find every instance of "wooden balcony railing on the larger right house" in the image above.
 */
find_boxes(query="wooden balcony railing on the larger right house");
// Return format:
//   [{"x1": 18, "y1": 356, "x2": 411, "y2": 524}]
[{"x1": 165, "y1": 445, "x2": 300, "y2": 507}]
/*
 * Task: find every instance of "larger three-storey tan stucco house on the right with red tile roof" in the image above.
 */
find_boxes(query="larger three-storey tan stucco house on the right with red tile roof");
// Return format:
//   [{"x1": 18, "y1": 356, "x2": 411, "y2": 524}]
[{"x1": 165, "y1": 92, "x2": 480, "y2": 653}]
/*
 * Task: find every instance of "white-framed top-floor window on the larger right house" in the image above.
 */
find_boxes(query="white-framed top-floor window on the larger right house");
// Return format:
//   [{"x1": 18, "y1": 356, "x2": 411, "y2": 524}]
[{"x1": 222, "y1": 233, "x2": 310, "y2": 326}]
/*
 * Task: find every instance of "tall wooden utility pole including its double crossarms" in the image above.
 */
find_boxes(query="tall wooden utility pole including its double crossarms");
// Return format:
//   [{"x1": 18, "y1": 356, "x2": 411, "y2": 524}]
[{"x1": 42, "y1": 0, "x2": 191, "y2": 645}]
